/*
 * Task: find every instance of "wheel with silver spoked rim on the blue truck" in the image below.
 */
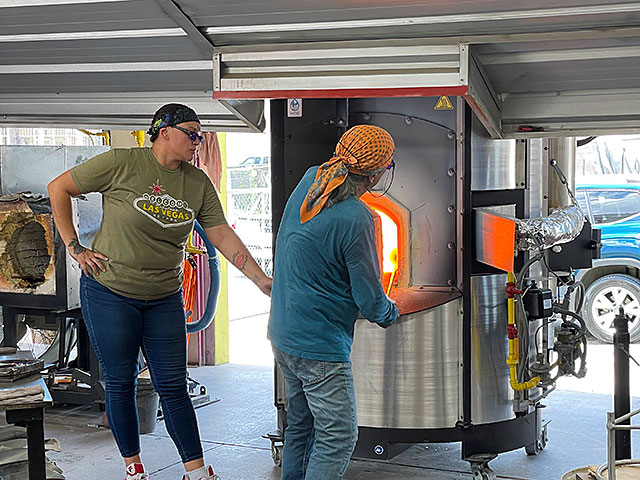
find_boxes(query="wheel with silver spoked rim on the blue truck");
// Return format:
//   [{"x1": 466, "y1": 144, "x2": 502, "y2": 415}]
[{"x1": 582, "y1": 274, "x2": 640, "y2": 343}]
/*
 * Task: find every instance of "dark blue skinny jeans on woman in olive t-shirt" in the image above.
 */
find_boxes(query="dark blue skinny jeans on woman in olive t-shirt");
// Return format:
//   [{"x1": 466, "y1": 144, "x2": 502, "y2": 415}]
[{"x1": 80, "y1": 275, "x2": 202, "y2": 462}]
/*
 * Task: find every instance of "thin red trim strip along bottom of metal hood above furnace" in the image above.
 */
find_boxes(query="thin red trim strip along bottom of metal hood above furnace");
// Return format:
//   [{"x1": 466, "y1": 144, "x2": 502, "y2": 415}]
[{"x1": 213, "y1": 85, "x2": 469, "y2": 100}]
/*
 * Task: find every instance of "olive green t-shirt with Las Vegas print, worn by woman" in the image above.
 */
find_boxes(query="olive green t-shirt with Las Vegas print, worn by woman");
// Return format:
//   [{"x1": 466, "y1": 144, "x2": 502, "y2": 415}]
[{"x1": 71, "y1": 148, "x2": 226, "y2": 300}]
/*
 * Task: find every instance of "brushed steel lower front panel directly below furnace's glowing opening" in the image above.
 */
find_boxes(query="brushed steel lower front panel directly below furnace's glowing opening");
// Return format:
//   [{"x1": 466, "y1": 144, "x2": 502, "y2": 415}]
[{"x1": 351, "y1": 298, "x2": 462, "y2": 428}]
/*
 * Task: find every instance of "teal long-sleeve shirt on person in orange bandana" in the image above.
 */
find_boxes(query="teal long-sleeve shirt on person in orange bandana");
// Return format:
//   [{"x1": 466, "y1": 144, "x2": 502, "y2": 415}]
[{"x1": 268, "y1": 167, "x2": 398, "y2": 362}]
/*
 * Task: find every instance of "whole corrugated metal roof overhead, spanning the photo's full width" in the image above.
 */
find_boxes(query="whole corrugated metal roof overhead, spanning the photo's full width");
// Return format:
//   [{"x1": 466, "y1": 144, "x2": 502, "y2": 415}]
[{"x1": 0, "y1": 0, "x2": 640, "y2": 136}]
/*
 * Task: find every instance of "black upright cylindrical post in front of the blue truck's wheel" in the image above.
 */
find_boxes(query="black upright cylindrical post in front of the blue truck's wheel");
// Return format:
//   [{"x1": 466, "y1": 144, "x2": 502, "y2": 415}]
[{"x1": 613, "y1": 307, "x2": 631, "y2": 460}]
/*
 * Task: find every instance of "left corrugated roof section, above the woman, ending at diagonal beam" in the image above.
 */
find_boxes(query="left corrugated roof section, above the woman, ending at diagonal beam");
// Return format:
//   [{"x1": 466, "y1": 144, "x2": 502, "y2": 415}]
[{"x1": 0, "y1": 0, "x2": 264, "y2": 131}]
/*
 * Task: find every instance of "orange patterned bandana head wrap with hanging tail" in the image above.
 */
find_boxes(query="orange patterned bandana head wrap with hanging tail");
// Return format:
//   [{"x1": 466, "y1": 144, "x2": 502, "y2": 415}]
[{"x1": 300, "y1": 125, "x2": 396, "y2": 223}]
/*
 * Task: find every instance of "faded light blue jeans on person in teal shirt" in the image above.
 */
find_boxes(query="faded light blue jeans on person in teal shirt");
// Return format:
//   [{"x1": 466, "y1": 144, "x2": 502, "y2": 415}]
[{"x1": 273, "y1": 347, "x2": 358, "y2": 480}]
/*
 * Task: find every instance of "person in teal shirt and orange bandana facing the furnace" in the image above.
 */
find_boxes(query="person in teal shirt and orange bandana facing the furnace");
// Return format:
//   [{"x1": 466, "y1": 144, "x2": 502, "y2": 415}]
[{"x1": 268, "y1": 125, "x2": 398, "y2": 480}]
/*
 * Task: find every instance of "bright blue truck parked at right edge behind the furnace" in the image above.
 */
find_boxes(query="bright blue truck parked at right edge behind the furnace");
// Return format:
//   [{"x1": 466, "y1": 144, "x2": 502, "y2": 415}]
[{"x1": 576, "y1": 183, "x2": 640, "y2": 342}]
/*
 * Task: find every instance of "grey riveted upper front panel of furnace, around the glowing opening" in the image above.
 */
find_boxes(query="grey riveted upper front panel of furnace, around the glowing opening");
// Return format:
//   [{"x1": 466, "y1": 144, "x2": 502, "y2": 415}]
[{"x1": 349, "y1": 98, "x2": 458, "y2": 287}]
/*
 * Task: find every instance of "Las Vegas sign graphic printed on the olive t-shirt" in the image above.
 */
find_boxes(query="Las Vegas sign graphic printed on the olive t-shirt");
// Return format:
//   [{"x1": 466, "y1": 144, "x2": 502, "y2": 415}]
[{"x1": 133, "y1": 179, "x2": 195, "y2": 228}]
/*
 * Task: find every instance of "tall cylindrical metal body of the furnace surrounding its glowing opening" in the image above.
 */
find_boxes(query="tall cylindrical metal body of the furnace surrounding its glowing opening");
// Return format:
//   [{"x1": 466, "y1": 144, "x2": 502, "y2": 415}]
[{"x1": 267, "y1": 97, "x2": 588, "y2": 478}]
